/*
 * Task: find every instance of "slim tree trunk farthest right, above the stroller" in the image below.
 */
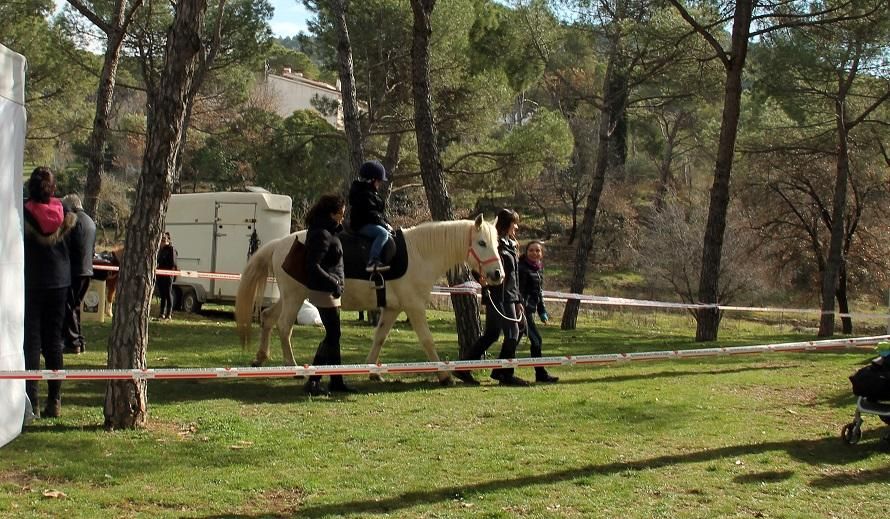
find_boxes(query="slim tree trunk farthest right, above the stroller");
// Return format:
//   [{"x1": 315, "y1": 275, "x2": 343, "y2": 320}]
[{"x1": 819, "y1": 100, "x2": 850, "y2": 337}]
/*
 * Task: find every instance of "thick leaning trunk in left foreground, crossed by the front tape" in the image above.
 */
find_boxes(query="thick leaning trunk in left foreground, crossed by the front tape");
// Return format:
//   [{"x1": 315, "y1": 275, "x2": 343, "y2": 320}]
[{"x1": 105, "y1": 0, "x2": 207, "y2": 430}]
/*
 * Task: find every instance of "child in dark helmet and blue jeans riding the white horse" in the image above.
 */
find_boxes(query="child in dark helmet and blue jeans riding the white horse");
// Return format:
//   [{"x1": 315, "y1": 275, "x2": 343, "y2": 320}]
[{"x1": 349, "y1": 160, "x2": 392, "y2": 272}]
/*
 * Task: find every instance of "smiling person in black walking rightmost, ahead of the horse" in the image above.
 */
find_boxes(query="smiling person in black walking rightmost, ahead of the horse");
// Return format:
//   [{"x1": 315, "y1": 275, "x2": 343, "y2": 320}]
[{"x1": 519, "y1": 240, "x2": 559, "y2": 384}]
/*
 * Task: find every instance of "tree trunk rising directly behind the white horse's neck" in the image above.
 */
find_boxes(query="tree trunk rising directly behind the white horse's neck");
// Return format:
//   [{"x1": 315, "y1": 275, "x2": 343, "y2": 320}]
[{"x1": 411, "y1": 0, "x2": 482, "y2": 353}]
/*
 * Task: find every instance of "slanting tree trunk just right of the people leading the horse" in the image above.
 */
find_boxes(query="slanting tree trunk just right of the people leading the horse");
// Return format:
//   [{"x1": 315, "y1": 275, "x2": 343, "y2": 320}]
[{"x1": 561, "y1": 50, "x2": 618, "y2": 330}]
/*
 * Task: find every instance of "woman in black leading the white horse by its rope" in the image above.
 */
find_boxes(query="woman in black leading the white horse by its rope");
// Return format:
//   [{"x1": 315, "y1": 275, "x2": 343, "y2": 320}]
[{"x1": 454, "y1": 209, "x2": 528, "y2": 386}]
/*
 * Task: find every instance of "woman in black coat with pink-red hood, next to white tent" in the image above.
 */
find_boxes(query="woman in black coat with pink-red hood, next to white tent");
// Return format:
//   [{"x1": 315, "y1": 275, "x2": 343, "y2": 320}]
[{"x1": 24, "y1": 167, "x2": 77, "y2": 418}]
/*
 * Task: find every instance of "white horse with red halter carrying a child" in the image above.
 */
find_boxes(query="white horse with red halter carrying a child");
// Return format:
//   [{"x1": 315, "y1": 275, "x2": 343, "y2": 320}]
[{"x1": 235, "y1": 214, "x2": 504, "y2": 384}]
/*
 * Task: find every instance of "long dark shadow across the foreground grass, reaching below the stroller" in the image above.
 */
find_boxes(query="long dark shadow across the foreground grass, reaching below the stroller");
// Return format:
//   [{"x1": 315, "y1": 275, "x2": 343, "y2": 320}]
[{"x1": 191, "y1": 438, "x2": 890, "y2": 518}]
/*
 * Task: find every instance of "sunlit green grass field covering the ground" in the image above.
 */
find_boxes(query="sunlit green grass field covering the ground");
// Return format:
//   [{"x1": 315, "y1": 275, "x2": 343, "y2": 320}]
[{"x1": 0, "y1": 306, "x2": 890, "y2": 518}]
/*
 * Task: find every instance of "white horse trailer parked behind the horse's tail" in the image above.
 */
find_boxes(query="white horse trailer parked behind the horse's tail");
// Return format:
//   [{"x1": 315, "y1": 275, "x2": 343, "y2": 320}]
[{"x1": 166, "y1": 188, "x2": 292, "y2": 312}]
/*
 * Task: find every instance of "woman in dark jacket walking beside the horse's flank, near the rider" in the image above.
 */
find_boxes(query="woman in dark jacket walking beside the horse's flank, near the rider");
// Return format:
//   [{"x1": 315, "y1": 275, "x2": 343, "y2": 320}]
[{"x1": 306, "y1": 195, "x2": 352, "y2": 396}]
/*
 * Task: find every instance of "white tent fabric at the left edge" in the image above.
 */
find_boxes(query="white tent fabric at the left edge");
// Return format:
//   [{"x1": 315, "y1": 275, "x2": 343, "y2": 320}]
[{"x1": 0, "y1": 45, "x2": 26, "y2": 446}]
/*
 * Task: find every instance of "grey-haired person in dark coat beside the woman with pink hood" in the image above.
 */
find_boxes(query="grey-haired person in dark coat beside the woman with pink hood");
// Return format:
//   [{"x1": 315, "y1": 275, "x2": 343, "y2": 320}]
[{"x1": 62, "y1": 194, "x2": 96, "y2": 354}]
